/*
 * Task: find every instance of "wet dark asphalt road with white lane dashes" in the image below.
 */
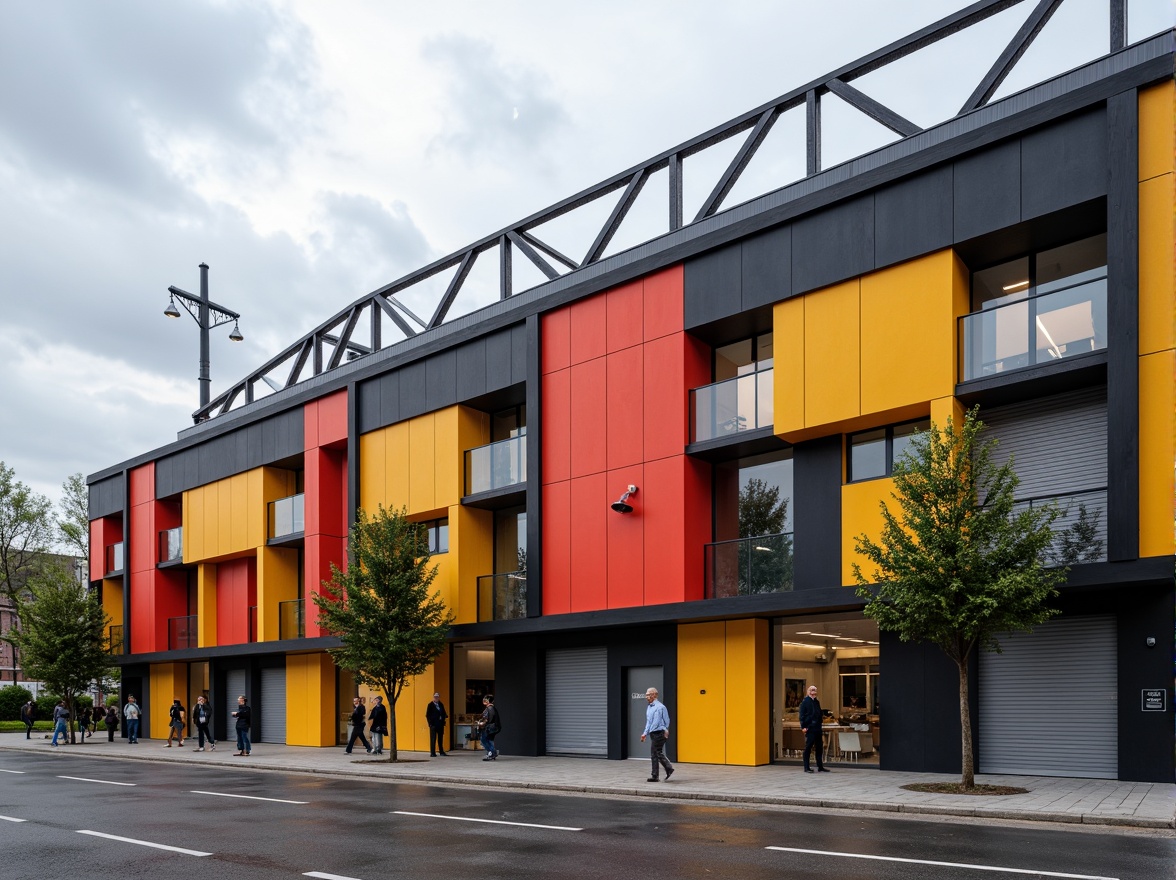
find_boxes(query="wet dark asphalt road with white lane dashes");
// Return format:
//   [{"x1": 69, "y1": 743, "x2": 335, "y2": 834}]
[{"x1": 0, "y1": 753, "x2": 1176, "y2": 880}]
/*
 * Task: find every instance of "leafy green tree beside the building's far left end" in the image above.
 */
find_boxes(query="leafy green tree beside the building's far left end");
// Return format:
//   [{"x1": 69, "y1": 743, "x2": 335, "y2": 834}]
[{"x1": 5, "y1": 564, "x2": 111, "y2": 741}]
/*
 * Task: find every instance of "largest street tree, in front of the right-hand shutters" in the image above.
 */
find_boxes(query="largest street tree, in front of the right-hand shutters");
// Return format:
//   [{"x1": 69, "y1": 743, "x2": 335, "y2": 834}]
[{"x1": 854, "y1": 408, "x2": 1067, "y2": 789}]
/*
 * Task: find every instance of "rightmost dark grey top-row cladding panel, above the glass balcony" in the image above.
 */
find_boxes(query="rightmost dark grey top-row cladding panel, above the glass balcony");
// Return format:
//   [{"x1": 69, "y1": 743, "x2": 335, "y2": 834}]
[{"x1": 1021, "y1": 108, "x2": 1107, "y2": 220}]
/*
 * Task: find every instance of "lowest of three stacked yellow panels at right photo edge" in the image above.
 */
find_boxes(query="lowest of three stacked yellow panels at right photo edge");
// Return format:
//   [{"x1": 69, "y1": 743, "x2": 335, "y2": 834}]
[{"x1": 1140, "y1": 351, "x2": 1176, "y2": 556}]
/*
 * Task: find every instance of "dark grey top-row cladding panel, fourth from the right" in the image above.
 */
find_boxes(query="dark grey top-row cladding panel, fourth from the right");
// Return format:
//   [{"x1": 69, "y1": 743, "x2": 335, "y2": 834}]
[{"x1": 793, "y1": 193, "x2": 874, "y2": 293}]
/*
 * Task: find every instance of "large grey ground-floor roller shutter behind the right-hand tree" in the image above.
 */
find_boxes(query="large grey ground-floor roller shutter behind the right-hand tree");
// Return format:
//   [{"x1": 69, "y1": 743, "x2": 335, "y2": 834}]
[{"x1": 980, "y1": 615, "x2": 1118, "y2": 779}]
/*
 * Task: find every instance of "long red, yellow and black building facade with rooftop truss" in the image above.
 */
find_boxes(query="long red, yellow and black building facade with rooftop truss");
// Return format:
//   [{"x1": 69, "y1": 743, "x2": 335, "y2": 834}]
[{"x1": 89, "y1": 4, "x2": 1176, "y2": 781}]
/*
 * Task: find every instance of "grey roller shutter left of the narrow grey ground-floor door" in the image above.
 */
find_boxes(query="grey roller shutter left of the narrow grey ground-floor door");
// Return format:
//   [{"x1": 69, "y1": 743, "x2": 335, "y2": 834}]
[{"x1": 545, "y1": 647, "x2": 608, "y2": 758}]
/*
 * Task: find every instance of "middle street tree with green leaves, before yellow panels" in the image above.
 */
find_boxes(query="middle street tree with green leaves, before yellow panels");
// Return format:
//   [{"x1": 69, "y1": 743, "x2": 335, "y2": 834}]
[{"x1": 310, "y1": 505, "x2": 453, "y2": 761}]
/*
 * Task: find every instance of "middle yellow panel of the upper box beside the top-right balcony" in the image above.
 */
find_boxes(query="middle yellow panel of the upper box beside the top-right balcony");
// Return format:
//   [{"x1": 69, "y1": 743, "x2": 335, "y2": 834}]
[{"x1": 804, "y1": 279, "x2": 861, "y2": 426}]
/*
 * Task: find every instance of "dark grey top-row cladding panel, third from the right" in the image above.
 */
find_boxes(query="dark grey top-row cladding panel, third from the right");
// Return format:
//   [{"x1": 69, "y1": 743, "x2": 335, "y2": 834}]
[{"x1": 874, "y1": 165, "x2": 953, "y2": 267}]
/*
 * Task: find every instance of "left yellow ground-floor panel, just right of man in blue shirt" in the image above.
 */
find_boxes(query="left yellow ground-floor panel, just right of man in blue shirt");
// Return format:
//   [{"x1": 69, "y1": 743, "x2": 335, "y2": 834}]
[{"x1": 669, "y1": 621, "x2": 724, "y2": 764}]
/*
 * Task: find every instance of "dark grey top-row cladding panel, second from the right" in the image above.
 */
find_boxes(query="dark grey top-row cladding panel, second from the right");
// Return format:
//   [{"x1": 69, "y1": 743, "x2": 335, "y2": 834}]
[{"x1": 953, "y1": 140, "x2": 1021, "y2": 241}]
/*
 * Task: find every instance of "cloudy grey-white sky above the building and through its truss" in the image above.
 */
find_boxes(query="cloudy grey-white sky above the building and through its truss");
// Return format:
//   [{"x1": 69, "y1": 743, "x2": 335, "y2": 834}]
[{"x1": 0, "y1": 0, "x2": 1174, "y2": 508}]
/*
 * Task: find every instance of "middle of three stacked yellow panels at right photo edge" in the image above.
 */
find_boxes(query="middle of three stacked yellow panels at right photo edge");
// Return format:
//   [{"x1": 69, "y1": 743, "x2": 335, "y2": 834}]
[{"x1": 1140, "y1": 173, "x2": 1176, "y2": 354}]
